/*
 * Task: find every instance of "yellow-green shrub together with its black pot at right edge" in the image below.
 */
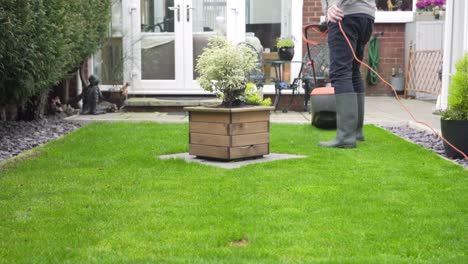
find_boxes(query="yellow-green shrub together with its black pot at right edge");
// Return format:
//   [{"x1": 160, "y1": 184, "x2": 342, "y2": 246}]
[{"x1": 441, "y1": 53, "x2": 468, "y2": 158}]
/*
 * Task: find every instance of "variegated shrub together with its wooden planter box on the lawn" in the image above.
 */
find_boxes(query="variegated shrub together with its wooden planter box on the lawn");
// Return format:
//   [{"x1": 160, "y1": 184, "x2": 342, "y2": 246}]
[{"x1": 184, "y1": 38, "x2": 273, "y2": 160}]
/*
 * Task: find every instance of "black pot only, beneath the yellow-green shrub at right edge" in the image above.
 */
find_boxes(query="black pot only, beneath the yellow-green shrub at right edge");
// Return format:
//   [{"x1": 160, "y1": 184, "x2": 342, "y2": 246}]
[{"x1": 440, "y1": 118, "x2": 468, "y2": 159}]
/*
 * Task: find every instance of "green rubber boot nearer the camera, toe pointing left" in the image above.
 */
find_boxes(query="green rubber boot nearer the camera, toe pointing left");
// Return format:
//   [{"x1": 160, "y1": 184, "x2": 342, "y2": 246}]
[{"x1": 319, "y1": 93, "x2": 358, "y2": 148}]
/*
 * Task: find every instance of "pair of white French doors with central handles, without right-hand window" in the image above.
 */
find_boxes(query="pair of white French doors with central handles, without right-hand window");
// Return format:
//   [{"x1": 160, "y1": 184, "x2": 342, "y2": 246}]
[{"x1": 124, "y1": 0, "x2": 238, "y2": 94}]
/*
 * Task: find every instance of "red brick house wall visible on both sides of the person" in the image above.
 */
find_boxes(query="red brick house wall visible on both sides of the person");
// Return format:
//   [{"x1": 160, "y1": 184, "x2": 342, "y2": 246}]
[{"x1": 303, "y1": 0, "x2": 405, "y2": 95}]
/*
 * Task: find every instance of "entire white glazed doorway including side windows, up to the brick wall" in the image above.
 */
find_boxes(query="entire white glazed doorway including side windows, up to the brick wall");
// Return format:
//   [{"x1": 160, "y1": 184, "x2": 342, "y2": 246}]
[{"x1": 119, "y1": 0, "x2": 302, "y2": 94}]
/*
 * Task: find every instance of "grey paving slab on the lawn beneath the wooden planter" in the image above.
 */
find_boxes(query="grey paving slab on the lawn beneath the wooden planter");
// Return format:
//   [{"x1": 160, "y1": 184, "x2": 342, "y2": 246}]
[{"x1": 158, "y1": 152, "x2": 307, "y2": 169}]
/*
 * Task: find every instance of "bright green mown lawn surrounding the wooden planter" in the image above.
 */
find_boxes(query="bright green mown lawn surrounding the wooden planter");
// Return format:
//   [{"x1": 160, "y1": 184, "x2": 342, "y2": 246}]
[{"x1": 0, "y1": 123, "x2": 468, "y2": 263}]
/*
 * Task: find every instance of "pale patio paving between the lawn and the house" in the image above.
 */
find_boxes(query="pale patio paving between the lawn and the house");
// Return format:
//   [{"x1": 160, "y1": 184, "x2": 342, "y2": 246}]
[{"x1": 67, "y1": 96, "x2": 440, "y2": 131}]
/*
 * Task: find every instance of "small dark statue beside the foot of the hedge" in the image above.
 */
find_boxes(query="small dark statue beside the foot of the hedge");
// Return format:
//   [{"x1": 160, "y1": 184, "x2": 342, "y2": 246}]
[{"x1": 81, "y1": 75, "x2": 105, "y2": 115}]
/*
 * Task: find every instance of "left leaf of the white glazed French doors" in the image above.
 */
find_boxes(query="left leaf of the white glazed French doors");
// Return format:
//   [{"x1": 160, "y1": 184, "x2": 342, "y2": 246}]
[{"x1": 129, "y1": 0, "x2": 184, "y2": 93}]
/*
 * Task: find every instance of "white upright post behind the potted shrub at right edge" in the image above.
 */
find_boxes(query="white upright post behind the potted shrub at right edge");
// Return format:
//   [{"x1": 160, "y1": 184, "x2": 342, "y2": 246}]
[{"x1": 436, "y1": 0, "x2": 455, "y2": 111}]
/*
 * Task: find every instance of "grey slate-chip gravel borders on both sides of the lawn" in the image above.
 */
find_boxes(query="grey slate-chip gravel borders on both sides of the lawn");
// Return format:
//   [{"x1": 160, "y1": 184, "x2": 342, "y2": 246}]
[{"x1": 0, "y1": 116, "x2": 468, "y2": 168}]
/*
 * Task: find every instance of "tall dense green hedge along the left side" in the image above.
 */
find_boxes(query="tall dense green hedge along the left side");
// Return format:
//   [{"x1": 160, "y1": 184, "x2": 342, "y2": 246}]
[{"x1": 0, "y1": 0, "x2": 110, "y2": 105}]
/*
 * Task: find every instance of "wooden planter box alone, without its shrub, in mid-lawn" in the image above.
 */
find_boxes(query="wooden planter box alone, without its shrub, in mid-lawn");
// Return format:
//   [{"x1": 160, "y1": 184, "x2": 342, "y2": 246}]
[{"x1": 184, "y1": 106, "x2": 274, "y2": 160}]
